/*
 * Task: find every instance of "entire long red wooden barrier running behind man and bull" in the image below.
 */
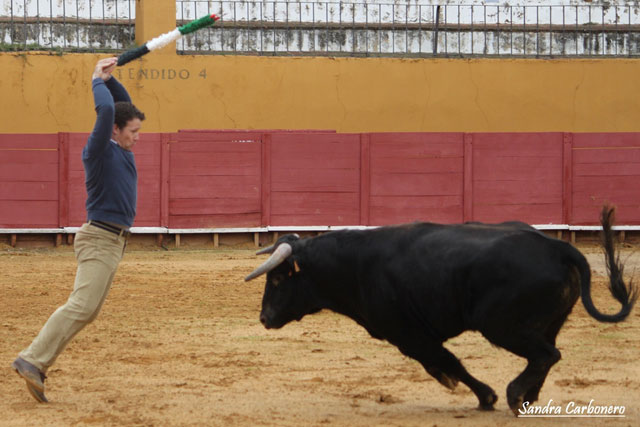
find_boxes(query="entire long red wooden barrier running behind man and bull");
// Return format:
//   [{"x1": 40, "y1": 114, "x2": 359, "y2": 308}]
[{"x1": 0, "y1": 130, "x2": 640, "y2": 228}]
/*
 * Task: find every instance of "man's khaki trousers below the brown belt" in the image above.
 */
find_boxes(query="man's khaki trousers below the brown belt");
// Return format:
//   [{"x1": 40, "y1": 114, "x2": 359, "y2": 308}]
[{"x1": 20, "y1": 224, "x2": 126, "y2": 372}]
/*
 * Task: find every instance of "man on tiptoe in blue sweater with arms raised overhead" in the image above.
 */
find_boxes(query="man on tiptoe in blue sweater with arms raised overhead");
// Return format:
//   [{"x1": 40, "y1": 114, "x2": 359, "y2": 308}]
[{"x1": 11, "y1": 58, "x2": 145, "y2": 403}]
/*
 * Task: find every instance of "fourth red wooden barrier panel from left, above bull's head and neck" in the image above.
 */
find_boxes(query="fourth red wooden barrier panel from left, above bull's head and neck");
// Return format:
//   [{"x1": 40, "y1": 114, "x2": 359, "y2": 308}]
[{"x1": 268, "y1": 133, "x2": 360, "y2": 226}]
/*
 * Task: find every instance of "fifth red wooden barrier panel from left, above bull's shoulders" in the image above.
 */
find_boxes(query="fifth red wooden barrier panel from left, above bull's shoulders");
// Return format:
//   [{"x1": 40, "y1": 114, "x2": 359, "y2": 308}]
[{"x1": 369, "y1": 133, "x2": 464, "y2": 225}]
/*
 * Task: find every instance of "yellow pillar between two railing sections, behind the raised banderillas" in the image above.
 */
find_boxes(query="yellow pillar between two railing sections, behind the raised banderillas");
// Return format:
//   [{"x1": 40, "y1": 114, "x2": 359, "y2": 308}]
[{"x1": 136, "y1": 0, "x2": 176, "y2": 55}]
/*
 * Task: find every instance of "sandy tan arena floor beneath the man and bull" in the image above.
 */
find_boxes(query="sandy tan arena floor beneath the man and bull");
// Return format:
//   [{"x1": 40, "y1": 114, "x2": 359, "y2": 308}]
[{"x1": 0, "y1": 245, "x2": 640, "y2": 426}]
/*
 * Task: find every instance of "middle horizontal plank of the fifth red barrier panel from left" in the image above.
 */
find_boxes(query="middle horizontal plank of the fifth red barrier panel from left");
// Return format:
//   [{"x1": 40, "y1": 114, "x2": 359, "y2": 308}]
[{"x1": 371, "y1": 173, "x2": 463, "y2": 196}]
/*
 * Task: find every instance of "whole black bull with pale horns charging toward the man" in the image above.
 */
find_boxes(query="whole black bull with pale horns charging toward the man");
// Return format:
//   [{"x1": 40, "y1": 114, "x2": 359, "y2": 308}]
[{"x1": 245, "y1": 207, "x2": 637, "y2": 414}]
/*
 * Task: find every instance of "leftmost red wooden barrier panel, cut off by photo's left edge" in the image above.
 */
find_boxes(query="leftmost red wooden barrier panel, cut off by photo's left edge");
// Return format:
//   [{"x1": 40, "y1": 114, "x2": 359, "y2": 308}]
[{"x1": 0, "y1": 134, "x2": 58, "y2": 228}]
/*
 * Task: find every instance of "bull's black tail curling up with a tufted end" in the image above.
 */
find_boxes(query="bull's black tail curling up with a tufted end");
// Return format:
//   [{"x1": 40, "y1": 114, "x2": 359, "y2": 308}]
[{"x1": 578, "y1": 206, "x2": 638, "y2": 323}]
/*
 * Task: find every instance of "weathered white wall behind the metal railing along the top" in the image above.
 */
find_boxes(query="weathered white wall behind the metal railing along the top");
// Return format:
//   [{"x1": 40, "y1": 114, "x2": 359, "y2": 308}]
[{"x1": 0, "y1": 0, "x2": 640, "y2": 56}]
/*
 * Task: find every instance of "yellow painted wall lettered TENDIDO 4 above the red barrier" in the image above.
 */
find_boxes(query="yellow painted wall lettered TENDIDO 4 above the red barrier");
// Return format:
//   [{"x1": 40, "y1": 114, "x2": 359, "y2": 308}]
[{"x1": 0, "y1": 49, "x2": 640, "y2": 133}]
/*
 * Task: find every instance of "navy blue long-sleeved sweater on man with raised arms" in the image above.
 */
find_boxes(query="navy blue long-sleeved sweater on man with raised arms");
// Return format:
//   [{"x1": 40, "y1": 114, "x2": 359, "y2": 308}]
[{"x1": 82, "y1": 77, "x2": 138, "y2": 227}]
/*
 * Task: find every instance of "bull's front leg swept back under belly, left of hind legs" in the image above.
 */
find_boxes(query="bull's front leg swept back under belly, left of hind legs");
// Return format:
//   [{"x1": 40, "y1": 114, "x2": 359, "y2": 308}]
[{"x1": 398, "y1": 342, "x2": 498, "y2": 411}]
